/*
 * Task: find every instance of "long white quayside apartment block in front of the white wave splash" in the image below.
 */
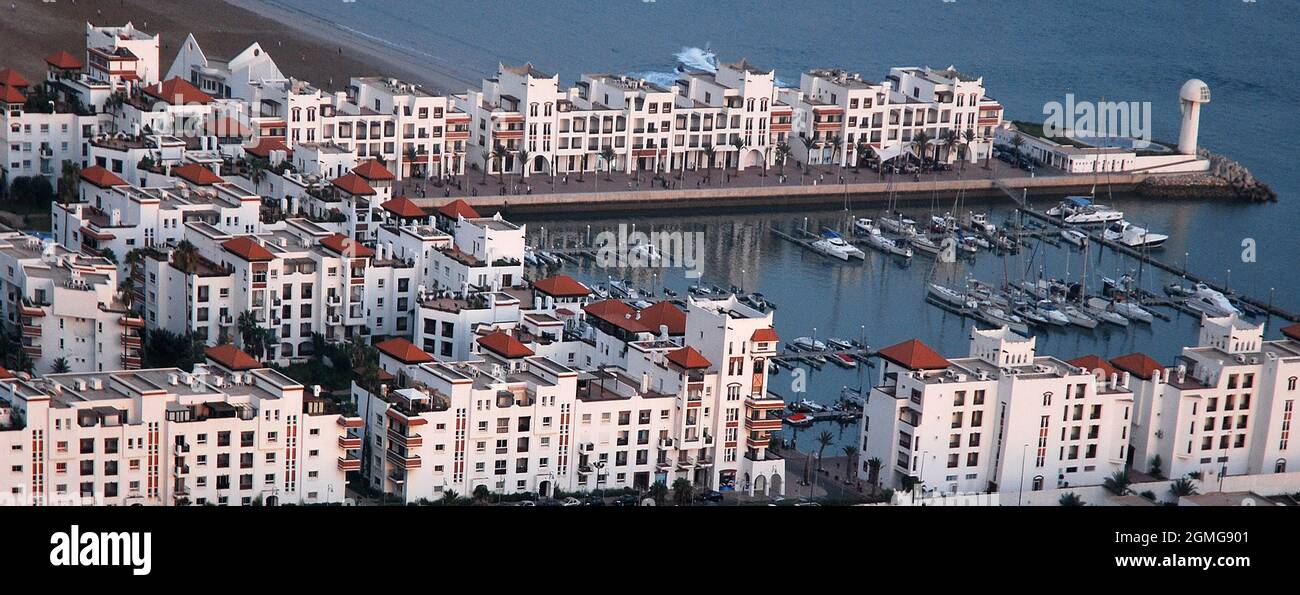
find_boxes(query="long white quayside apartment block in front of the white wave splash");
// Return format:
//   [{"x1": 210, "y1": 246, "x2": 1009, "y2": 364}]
[{"x1": 454, "y1": 60, "x2": 792, "y2": 178}]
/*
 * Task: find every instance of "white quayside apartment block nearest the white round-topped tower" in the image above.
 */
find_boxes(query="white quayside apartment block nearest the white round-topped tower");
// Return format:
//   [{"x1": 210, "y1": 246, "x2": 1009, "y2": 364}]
[{"x1": 783, "y1": 66, "x2": 1002, "y2": 166}]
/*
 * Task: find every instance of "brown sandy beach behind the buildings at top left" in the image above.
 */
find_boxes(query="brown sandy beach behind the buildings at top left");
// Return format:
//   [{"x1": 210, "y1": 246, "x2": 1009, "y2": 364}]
[{"x1": 0, "y1": 0, "x2": 477, "y2": 92}]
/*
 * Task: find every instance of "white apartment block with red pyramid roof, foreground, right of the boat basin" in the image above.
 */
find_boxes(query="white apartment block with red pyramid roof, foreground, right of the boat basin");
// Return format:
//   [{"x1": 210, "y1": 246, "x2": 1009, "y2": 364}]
[{"x1": 858, "y1": 327, "x2": 1134, "y2": 494}]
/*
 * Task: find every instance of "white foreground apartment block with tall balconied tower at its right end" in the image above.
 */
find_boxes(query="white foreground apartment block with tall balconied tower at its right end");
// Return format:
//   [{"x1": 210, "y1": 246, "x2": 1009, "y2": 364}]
[{"x1": 354, "y1": 293, "x2": 785, "y2": 501}]
